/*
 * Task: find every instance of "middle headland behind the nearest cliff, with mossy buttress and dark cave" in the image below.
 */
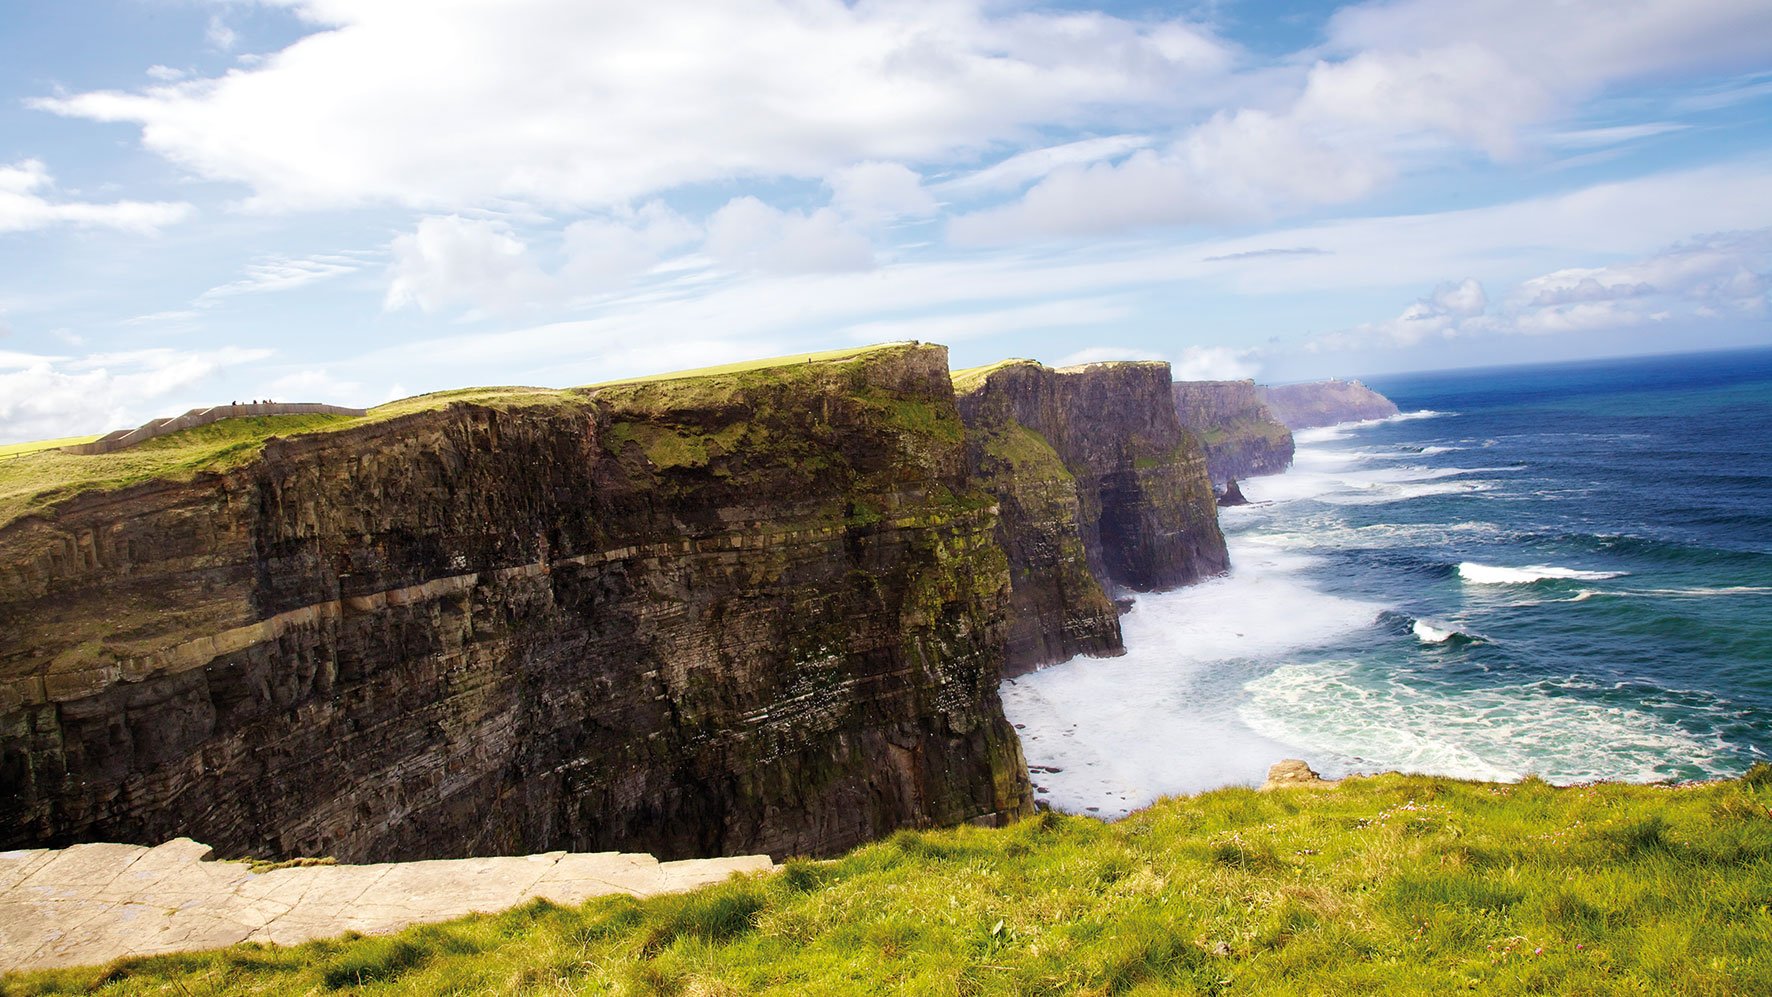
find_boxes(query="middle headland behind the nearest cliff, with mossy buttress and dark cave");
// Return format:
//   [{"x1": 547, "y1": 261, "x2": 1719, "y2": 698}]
[{"x1": 955, "y1": 359, "x2": 1230, "y2": 675}]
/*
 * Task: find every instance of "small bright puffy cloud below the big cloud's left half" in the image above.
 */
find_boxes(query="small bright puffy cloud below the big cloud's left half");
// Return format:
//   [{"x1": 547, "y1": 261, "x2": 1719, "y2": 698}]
[{"x1": 383, "y1": 214, "x2": 548, "y2": 312}]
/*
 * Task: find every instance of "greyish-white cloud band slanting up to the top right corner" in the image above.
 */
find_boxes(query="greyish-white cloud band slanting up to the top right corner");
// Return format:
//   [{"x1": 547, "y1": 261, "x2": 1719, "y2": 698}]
[{"x1": 950, "y1": 0, "x2": 1772, "y2": 243}]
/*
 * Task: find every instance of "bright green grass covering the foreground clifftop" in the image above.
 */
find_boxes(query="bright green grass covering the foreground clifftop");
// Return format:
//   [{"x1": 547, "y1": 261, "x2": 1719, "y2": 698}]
[{"x1": 13, "y1": 767, "x2": 1772, "y2": 995}]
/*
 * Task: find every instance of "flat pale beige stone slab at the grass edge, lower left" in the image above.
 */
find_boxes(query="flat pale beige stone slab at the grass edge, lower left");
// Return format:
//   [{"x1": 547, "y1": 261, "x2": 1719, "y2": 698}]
[{"x1": 0, "y1": 838, "x2": 773, "y2": 972}]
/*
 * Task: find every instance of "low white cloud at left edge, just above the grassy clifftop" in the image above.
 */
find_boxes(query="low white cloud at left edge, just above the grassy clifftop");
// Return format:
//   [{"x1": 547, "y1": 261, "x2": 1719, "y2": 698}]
[{"x1": 0, "y1": 347, "x2": 271, "y2": 439}]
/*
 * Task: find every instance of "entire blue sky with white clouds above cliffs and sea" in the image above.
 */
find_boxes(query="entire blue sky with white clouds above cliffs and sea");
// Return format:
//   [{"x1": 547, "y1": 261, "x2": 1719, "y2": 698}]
[{"x1": 0, "y1": 0, "x2": 1772, "y2": 443}]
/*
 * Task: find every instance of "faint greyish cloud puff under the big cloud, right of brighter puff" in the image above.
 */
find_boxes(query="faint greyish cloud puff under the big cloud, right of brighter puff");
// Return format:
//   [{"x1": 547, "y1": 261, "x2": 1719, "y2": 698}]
[{"x1": 703, "y1": 195, "x2": 874, "y2": 273}]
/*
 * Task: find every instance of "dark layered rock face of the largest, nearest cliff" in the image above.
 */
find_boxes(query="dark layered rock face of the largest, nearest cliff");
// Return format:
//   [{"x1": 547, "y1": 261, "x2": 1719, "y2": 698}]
[{"x1": 0, "y1": 344, "x2": 1034, "y2": 862}]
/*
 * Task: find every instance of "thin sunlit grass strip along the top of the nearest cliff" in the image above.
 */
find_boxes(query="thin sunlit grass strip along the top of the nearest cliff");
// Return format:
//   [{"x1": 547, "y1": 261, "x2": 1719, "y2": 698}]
[{"x1": 0, "y1": 344, "x2": 904, "y2": 526}]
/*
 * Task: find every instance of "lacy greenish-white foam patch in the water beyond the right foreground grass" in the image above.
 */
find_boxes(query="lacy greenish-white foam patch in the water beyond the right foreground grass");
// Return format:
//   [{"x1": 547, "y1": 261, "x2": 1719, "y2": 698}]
[{"x1": 1240, "y1": 661, "x2": 1726, "y2": 783}]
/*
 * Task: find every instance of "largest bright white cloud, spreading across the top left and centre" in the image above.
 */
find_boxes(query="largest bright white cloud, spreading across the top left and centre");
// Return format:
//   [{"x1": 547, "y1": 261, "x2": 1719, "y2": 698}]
[{"x1": 32, "y1": 0, "x2": 1232, "y2": 213}]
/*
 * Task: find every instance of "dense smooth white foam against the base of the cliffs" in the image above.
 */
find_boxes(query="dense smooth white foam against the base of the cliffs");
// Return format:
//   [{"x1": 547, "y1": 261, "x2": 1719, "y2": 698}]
[{"x1": 1003, "y1": 537, "x2": 1384, "y2": 816}]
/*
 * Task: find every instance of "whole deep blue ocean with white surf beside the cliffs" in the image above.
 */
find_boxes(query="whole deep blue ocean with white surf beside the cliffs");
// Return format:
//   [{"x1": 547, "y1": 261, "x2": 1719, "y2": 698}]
[{"x1": 1003, "y1": 349, "x2": 1772, "y2": 816}]
